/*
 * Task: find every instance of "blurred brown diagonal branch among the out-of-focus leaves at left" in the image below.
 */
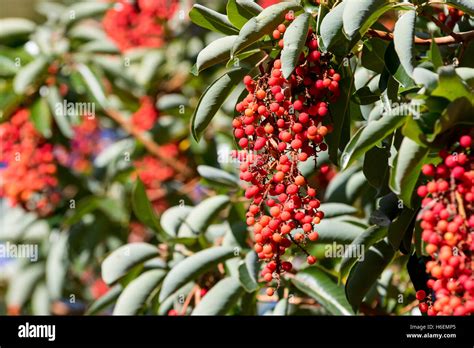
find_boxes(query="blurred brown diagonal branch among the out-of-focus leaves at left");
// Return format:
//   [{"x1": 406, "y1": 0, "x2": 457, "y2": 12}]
[{"x1": 105, "y1": 108, "x2": 192, "y2": 177}]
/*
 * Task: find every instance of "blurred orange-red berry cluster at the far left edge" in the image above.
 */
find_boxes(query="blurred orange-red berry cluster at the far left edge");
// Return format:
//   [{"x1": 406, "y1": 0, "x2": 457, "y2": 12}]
[{"x1": 0, "y1": 109, "x2": 61, "y2": 216}]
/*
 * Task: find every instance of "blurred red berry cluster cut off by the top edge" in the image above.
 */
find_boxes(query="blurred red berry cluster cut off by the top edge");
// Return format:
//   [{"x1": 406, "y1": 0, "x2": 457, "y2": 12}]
[{"x1": 102, "y1": 0, "x2": 179, "y2": 51}]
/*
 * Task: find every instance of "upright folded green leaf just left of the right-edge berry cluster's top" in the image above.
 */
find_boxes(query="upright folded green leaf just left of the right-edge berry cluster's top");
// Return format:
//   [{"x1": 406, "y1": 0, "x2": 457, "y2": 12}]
[{"x1": 389, "y1": 138, "x2": 429, "y2": 207}]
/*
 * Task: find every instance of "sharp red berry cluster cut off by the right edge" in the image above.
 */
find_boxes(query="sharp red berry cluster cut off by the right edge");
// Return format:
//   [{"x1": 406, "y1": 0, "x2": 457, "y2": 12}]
[{"x1": 417, "y1": 135, "x2": 474, "y2": 315}]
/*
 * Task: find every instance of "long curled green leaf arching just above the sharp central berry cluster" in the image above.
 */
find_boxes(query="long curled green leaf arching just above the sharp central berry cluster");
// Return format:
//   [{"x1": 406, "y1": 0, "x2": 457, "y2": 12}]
[{"x1": 231, "y1": 2, "x2": 302, "y2": 56}]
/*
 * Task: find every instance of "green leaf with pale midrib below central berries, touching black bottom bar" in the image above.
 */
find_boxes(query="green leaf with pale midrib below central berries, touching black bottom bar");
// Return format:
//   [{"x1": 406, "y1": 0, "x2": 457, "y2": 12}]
[{"x1": 291, "y1": 266, "x2": 354, "y2": 315}]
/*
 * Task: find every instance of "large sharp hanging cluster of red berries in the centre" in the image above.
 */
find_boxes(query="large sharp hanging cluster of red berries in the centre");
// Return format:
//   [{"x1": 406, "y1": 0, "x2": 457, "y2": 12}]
[{"x1": 232, "y1": 13, "x2": 341, "y2": 296}]
